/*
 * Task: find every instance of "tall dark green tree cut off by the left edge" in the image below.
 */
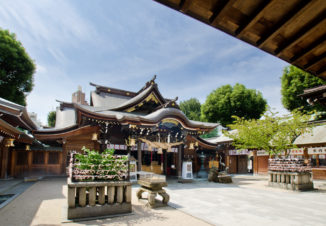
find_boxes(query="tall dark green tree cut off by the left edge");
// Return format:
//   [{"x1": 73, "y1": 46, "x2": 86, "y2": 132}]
[{"x1": 0, "y1": 29, "x2": 35, "y2": 105}]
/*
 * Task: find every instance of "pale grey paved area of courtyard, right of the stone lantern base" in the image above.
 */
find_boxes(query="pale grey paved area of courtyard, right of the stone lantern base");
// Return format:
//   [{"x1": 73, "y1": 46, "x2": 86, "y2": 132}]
[{"x1": 167, "y1": 176, "x2": 326, "y2": 226}]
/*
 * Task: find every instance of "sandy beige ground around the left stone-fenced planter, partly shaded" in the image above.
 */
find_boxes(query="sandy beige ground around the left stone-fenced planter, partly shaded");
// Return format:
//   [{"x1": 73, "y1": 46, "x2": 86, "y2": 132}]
[{"x1": 0, "y1": 178, "x2": 210, "y2": 226}]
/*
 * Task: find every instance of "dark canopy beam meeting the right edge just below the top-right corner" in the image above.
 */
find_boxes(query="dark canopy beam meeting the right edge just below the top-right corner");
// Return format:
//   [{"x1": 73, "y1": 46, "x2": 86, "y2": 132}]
[{"x1": 274, "y1": 10, "x2": 326, "y2": 57}]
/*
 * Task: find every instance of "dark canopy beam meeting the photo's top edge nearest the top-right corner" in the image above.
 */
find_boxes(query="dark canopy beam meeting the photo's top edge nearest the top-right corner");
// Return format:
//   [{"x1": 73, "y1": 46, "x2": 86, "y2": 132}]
[{"x1": 257, "y1": 0, "x2": 314, "y2": 48}]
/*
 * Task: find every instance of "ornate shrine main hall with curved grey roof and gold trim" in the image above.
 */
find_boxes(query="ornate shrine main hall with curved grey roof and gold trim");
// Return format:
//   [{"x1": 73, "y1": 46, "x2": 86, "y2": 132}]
[{"x1": 29, "y1": 76, "x2": 219, "y2": 178}]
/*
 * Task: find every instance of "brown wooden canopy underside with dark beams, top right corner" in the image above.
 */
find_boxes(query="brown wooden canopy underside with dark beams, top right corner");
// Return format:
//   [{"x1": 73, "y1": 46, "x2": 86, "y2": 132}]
[{"x1": 155, "y1": 0, "x2": 326, "y2": 80}]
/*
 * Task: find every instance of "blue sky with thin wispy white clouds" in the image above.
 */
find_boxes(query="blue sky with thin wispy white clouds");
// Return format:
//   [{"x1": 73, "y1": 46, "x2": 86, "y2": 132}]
[{"x1": 0, "y1": 0, "x2": 287, "y2": 123}]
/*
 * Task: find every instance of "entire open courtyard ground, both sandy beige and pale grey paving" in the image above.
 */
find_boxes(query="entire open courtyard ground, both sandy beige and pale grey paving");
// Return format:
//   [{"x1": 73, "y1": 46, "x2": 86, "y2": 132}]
[{"x1": 0, "y1": 175, "x2": 326, "y2": 226}]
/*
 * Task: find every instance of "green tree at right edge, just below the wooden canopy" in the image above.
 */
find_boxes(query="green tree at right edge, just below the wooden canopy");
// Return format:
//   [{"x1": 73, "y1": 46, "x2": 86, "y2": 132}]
[{"x1": 281, "y1": 65, "x2": 326, "y2": 112}]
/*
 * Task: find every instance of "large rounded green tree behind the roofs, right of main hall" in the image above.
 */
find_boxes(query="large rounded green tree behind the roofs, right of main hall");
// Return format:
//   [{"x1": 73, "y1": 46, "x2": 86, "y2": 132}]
[{"x1": 201, "y1": 83, "x2": 267, "y2": 126}]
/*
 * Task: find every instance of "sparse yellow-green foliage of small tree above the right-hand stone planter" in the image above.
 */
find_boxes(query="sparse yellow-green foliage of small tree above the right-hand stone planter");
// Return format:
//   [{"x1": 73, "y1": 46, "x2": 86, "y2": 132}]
[{"x1": 226, "y1": 110, "x2": 311, "y2": 155}]
